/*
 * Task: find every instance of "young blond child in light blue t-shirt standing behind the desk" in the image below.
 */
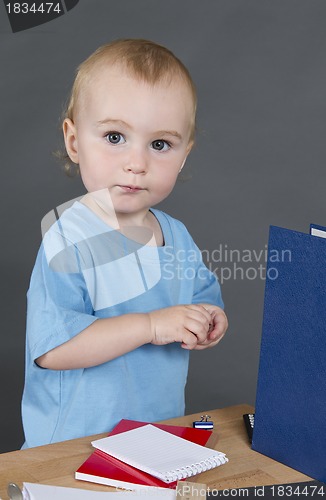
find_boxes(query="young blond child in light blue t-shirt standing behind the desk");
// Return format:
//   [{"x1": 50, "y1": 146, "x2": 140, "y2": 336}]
[{"x1": 22, "y1": 40, "x2": 227, "y2": 447}]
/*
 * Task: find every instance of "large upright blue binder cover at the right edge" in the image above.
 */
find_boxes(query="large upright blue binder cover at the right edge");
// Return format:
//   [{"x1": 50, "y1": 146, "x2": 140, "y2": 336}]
[{"x1": 252, "y1": 225, "x2": 326, "y2": 482}]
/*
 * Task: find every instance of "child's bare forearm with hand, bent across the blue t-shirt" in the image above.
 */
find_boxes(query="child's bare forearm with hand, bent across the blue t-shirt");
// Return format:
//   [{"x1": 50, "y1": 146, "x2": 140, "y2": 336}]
[{"x1": 36, "y1": 304, "x2": 213, "y2": 370}]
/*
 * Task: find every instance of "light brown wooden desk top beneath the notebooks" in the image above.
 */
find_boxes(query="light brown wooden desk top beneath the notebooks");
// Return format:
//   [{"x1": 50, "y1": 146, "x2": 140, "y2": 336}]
[{"x1": 0, "y1": 405, "x2": 311, "y2": 500}]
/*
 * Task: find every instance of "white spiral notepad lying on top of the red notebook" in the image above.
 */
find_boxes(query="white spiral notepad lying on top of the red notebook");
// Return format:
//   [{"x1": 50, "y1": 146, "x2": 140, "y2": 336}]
[{"x1": 92, "y1": 424, "x2": 228, "y2": 483}]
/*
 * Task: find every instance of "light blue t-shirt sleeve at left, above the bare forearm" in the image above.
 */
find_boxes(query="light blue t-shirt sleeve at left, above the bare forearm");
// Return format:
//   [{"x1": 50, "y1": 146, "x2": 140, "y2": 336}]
[{"x1": 27, "y1": 244, "x2": 97, "y2": 360}]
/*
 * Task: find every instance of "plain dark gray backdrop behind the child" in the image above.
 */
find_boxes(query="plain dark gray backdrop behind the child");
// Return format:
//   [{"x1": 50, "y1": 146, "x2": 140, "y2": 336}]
[{"x1": 0, "y1": 0, "x2": 326, "y2": 452}]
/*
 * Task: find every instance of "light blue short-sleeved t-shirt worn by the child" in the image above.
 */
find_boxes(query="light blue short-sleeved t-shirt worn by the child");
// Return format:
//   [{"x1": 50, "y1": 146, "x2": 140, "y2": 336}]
[{"x1": 22, "y1": 201, "x2": 223, "y2": 447}]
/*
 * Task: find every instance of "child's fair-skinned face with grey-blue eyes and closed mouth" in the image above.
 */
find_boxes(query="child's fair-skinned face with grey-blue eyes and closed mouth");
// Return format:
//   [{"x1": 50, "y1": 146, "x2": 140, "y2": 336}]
[{"x1": 64, "y1": 67, "x2": 193, "y2": 220}]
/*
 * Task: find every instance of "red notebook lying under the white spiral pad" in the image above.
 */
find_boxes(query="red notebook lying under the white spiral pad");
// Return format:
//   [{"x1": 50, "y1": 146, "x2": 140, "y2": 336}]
[{"x1": 75, "y1": 420, "x2": 217, "y2": 490}]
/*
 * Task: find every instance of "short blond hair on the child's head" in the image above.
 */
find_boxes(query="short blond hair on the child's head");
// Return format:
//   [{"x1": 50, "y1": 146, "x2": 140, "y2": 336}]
[{"x1": 64, "y1": 39, "x2": 197, "y2": 174}]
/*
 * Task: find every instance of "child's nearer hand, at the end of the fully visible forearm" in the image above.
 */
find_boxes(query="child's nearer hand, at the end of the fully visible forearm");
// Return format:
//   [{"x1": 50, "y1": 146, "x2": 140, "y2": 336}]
[{"x1": 149, "y1": 304, "x2": 214, "y2": 349}]
